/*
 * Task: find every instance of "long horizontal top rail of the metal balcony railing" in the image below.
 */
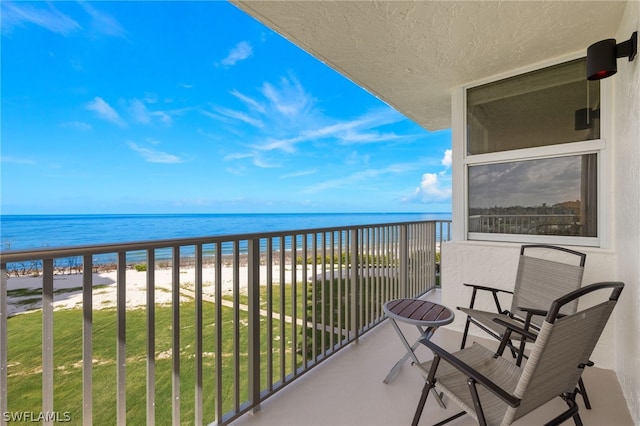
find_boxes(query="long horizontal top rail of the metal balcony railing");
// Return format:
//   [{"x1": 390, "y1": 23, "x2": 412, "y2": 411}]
[{"x1": 0, "y1": 220, "x2": 451, "y2": 264}]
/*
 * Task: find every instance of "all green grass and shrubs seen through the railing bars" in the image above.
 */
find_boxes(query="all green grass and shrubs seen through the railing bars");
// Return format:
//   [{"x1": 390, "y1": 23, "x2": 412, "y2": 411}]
[{"x1": 7, "y1": 272, "x2": 428, "y2": 425}]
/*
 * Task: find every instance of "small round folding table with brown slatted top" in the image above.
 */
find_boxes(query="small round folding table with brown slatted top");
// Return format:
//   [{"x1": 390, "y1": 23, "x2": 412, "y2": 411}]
[{"x1": 383, "y1": 299, "x2": 454, "y2": 383}]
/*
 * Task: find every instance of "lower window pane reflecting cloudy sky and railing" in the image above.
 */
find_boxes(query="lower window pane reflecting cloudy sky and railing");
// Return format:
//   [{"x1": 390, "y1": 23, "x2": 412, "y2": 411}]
[{"x1": 468, "y1": 154, "x2": 597, "y2": 237}]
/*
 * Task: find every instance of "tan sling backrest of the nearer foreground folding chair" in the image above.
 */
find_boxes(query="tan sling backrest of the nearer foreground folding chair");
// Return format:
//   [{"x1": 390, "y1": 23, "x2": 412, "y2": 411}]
[{"x1": 503, "y1": 282, "x2": 624, "y2": 424}]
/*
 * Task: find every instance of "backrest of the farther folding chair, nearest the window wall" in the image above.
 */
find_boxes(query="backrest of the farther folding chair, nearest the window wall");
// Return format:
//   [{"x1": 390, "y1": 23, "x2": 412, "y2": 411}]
[{"x1": 510, "y1": 245, "x2": 586, "y2": 327}]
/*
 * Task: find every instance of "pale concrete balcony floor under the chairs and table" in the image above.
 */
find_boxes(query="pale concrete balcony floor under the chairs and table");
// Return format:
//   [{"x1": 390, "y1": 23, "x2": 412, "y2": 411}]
[{"x1": 234, "y1": 293, "x2": 633, "y2": 426}]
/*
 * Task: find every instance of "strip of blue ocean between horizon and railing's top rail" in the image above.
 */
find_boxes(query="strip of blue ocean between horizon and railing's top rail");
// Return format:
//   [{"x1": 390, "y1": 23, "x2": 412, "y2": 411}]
[{"x1": 0, "y1": 213, "x2": 451, "y2": 250}]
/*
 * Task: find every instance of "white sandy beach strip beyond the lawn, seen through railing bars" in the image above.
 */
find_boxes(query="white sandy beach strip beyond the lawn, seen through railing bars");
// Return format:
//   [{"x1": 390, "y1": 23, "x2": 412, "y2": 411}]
[{"x1": 7, "y1": 265, "x2": 311, "y2": 316}]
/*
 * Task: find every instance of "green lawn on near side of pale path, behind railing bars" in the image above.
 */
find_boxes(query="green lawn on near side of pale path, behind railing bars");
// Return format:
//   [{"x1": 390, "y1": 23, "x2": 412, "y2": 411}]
[{"x1": 7, "y1": 302, "x2": 290, "y2": 424}]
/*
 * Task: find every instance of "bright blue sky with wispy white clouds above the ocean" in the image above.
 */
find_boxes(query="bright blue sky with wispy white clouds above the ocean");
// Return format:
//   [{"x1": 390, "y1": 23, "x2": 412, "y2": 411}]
[{"x1": 0, "y1": 1, "x2": 451, "y2": 214}]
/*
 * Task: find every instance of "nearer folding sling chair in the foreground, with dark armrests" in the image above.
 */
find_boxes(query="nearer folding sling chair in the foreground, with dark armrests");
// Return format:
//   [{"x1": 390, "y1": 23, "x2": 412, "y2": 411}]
[{"x1": 412, "y1": 282, "x2": 624, "y2": 426}]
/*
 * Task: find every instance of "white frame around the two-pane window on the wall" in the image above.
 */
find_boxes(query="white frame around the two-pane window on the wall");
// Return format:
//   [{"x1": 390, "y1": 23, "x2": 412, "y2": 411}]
[{"x1": 460, "y1": 56, "x2": 610, "y2": 247}]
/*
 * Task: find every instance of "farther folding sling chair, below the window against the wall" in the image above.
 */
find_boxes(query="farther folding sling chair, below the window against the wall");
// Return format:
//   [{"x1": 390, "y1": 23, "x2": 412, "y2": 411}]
[{"x1": 458, "y1": 244, "x2": 593, "y2": 409}]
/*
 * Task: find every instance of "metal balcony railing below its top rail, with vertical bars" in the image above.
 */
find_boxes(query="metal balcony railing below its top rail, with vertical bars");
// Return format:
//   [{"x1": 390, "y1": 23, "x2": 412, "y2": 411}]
[{"x1": 0, "y1": 221, "x2": 450, "y2": 425}]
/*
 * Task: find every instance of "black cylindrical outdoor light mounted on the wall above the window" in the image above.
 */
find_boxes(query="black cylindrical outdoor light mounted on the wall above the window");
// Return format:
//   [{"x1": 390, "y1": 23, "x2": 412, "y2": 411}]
[{"x1": 587, "y1": 31, "x2": 638, "y2": 80}]
